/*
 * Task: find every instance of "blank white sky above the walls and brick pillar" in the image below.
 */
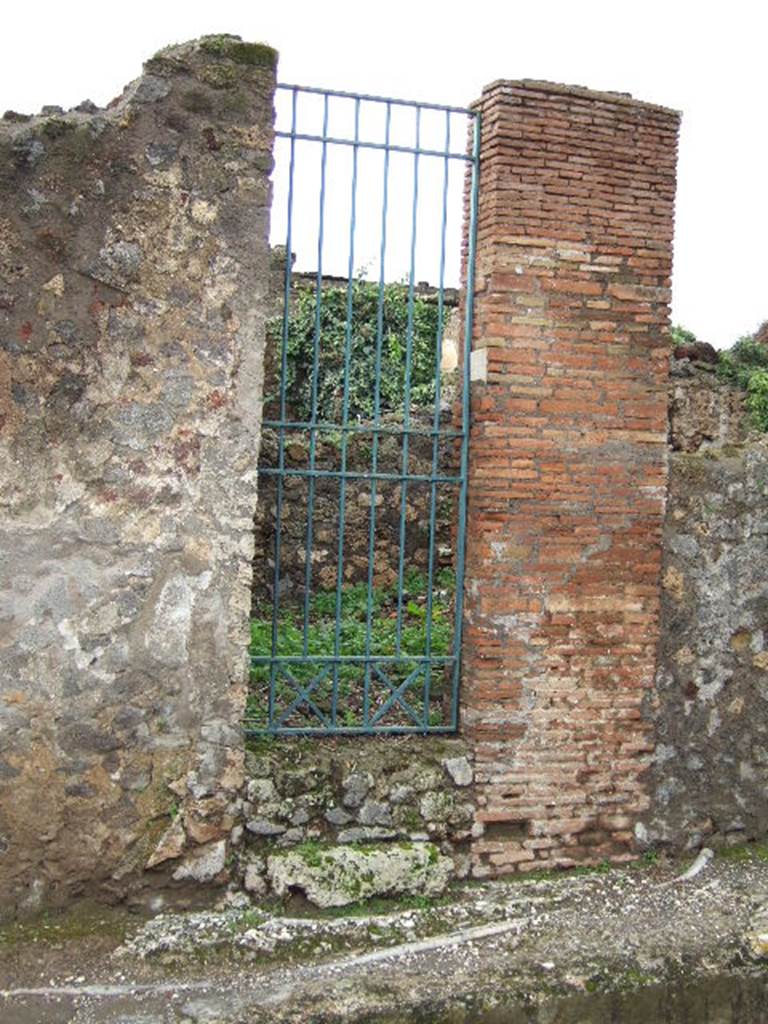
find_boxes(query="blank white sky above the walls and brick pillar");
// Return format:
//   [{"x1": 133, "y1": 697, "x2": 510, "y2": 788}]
[{"x1": 0, "y1": 0, "x2": 768, "y2": 347}]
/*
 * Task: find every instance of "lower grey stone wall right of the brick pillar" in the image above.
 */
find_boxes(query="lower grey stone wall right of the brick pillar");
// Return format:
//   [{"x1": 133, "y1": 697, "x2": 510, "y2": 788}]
[{"x1": 637, "y1": 372, "x2": 768, "y2": 851}]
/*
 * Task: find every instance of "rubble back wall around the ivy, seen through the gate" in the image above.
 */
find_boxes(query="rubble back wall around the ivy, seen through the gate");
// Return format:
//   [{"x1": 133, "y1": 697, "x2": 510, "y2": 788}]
[{"x1": 253, "y1": 264, "x2": 461, "y2": 606}]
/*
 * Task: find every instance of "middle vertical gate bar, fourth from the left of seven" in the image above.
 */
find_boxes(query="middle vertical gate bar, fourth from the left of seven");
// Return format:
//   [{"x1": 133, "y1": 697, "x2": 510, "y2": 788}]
[{"x1": 362, "y1": 102, "x2": 392, "y2": 729}]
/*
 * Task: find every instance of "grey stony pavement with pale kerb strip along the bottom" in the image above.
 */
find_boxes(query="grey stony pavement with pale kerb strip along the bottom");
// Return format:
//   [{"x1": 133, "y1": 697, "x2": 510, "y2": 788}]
[{"x1": 0, "y1": 857, "x2": 768, "y2": 1024}]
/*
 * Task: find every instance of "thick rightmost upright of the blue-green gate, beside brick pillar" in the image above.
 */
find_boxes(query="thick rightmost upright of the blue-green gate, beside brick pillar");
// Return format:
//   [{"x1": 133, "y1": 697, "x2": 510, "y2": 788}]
[{"x1": 451, "y1": 114, "x2": 481, "y2": 729}]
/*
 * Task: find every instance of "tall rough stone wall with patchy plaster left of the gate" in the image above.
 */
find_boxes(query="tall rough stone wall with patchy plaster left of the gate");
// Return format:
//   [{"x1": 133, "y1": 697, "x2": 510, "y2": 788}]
[{"x1": 0, "y1": 37, "x2": 275, "y2": 910}]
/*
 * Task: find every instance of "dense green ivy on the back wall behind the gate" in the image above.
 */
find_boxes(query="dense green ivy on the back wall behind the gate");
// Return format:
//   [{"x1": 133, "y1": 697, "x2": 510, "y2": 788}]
[{"x1": 266, "y1": 278, "x2": 438, "y2": 422}]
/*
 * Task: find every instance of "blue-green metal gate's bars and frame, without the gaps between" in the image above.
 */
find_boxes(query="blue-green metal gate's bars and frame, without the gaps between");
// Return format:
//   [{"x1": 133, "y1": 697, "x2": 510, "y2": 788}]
[{"x1": 245, "y1": 83, "x2": 480, "y2": 736}]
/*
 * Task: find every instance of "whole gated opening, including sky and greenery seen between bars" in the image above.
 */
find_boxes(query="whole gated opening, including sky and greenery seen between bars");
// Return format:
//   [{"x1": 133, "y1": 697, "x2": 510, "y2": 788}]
[{"x1": 246, "y1": 85, "x2": 479, "y2": 734}]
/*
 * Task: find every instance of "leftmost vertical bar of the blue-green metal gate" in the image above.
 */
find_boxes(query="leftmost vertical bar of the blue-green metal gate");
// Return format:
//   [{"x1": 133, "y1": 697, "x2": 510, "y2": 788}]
[{"x1": 267, "y1": 89, "x2": 298, "y2": 728}]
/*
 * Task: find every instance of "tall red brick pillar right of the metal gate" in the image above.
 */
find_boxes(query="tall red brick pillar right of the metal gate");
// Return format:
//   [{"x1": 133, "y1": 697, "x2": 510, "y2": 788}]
[{"x1": 463, "y1": 81, "x2": 679, "y2": 876}]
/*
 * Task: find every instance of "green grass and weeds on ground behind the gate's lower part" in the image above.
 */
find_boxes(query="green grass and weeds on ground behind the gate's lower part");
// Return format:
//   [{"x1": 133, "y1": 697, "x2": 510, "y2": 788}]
[{"x1": 246, "y1": 569, "x2": 456, "y2": 728}]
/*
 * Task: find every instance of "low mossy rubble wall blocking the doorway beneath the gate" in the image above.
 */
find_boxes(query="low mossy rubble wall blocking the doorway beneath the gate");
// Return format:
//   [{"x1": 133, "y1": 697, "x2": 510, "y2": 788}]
[{"x1": 236, "y1": 736, "x2": 475, "y2": 902}]
